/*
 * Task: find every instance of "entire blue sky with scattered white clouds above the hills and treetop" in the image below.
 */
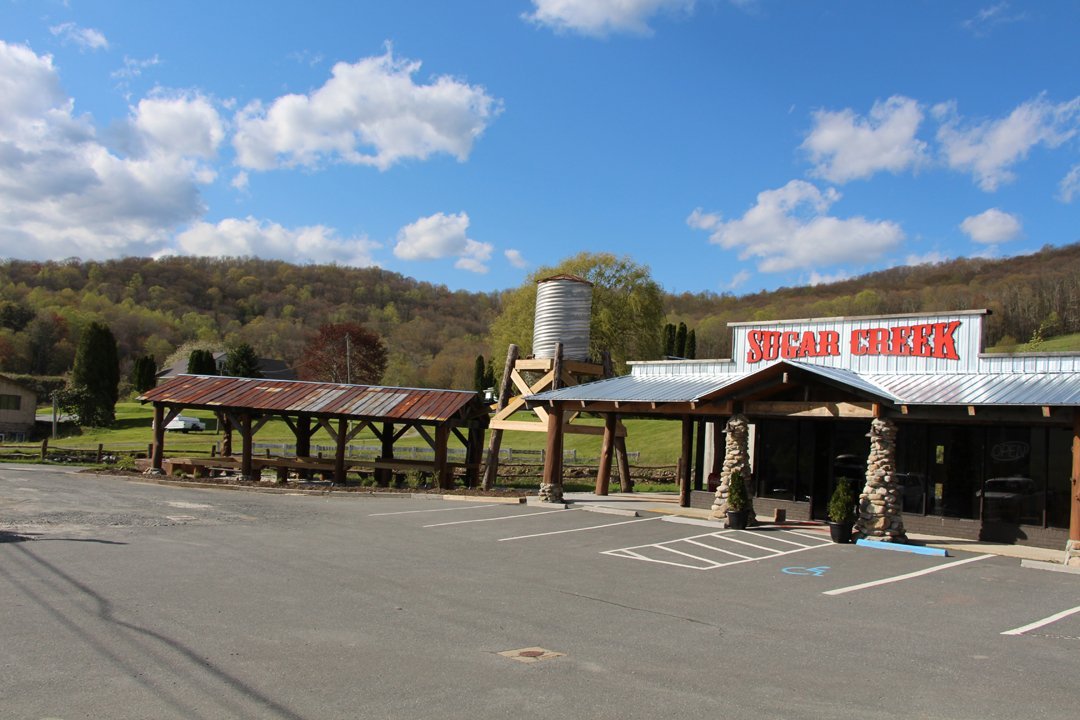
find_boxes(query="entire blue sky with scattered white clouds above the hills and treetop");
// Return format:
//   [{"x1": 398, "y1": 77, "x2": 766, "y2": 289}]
[{"x1": 0, "y1": 0, "x2": 1080, "y2": 294}]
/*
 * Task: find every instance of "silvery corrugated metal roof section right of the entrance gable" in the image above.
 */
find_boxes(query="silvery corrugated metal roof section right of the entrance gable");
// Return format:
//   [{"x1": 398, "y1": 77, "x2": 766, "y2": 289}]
[{"x1": 863, "y1": 372, "x2": 1080, "y2": 406}]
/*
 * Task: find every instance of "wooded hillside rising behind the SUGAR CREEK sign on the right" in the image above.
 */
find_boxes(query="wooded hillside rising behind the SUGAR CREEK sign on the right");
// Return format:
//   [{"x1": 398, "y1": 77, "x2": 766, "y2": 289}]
[{"x1": 667, "y1": 244, "x2": 1080, "y2": 357}]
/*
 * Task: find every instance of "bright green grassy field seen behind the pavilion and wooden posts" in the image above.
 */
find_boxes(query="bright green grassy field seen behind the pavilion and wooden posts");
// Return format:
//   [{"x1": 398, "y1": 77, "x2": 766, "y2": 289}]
[{"x1": 40, "y1": 403, "x2": 680, "y2": 466}]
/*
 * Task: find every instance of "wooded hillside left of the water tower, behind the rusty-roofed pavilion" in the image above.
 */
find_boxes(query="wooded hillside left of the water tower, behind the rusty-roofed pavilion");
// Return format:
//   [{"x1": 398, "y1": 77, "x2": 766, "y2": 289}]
[{"x1": 0, "y1": 257, "x2": 498, "y2": 388}]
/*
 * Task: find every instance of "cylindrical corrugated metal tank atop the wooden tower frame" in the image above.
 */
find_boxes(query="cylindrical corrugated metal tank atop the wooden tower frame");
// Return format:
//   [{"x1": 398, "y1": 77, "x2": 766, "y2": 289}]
[{"x1": 532, "y1": 275, "x2": 593, "y2": 362}]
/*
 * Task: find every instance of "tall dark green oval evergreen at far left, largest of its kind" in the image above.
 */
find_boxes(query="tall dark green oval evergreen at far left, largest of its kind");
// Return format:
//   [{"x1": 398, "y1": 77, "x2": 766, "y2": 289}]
[{"x1": 71, "y1": 323, "x2": 120, "y2": 426}]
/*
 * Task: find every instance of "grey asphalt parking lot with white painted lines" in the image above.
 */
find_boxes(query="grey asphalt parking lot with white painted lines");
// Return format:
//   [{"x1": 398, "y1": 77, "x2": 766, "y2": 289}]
[{"x1": 0, "y1": 465, "x2": 1080, "y2": 720}]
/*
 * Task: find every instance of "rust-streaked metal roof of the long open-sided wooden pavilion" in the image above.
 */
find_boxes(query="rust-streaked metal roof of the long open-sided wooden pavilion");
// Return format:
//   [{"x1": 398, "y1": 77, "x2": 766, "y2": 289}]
[{"x1": 138, "y1": 375, "x2": 483, "y2": 422}]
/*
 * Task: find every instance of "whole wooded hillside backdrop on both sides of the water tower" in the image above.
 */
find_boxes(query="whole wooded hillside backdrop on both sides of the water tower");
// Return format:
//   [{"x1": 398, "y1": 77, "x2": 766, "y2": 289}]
[{"x1": 0, "y1": 244, "x2": 1080, "y2": 388}]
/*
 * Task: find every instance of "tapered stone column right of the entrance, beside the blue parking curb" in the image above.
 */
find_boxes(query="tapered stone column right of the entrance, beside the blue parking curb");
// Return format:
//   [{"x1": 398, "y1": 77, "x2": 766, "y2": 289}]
[{"x1": 855, "y1": 418, "x2": 907, "y2": 543}]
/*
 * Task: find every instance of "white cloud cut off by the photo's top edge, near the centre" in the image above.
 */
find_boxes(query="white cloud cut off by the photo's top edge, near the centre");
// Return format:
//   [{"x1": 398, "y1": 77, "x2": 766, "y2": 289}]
[{"x1": 524, "y1": 0, "x2": 694, "y2": 37}]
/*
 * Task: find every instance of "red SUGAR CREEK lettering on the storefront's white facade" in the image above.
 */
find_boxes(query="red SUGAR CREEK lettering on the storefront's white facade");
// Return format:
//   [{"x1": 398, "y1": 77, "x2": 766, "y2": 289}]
[{"x1": 746, "y1": 321, "x2": 962, "y2": 365}]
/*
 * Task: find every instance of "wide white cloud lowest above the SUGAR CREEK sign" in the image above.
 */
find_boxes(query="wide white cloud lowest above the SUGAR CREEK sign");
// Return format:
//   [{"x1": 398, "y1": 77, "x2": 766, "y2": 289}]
[{"x1": 687, "y1": 180, "x2": 904, "y2": 272}]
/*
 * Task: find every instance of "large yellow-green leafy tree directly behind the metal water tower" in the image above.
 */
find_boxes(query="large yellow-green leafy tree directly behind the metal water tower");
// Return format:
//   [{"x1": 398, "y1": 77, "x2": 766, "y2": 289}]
[{"x1": 490, "y1": 253, "x2": 664, "y2": 369}]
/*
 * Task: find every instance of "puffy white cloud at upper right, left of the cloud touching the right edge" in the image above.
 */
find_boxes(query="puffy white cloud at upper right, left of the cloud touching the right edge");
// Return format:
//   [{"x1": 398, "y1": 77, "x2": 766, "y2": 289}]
[{"x1": 801, "y1": 95, "x2": 927, "y2": 182}]
